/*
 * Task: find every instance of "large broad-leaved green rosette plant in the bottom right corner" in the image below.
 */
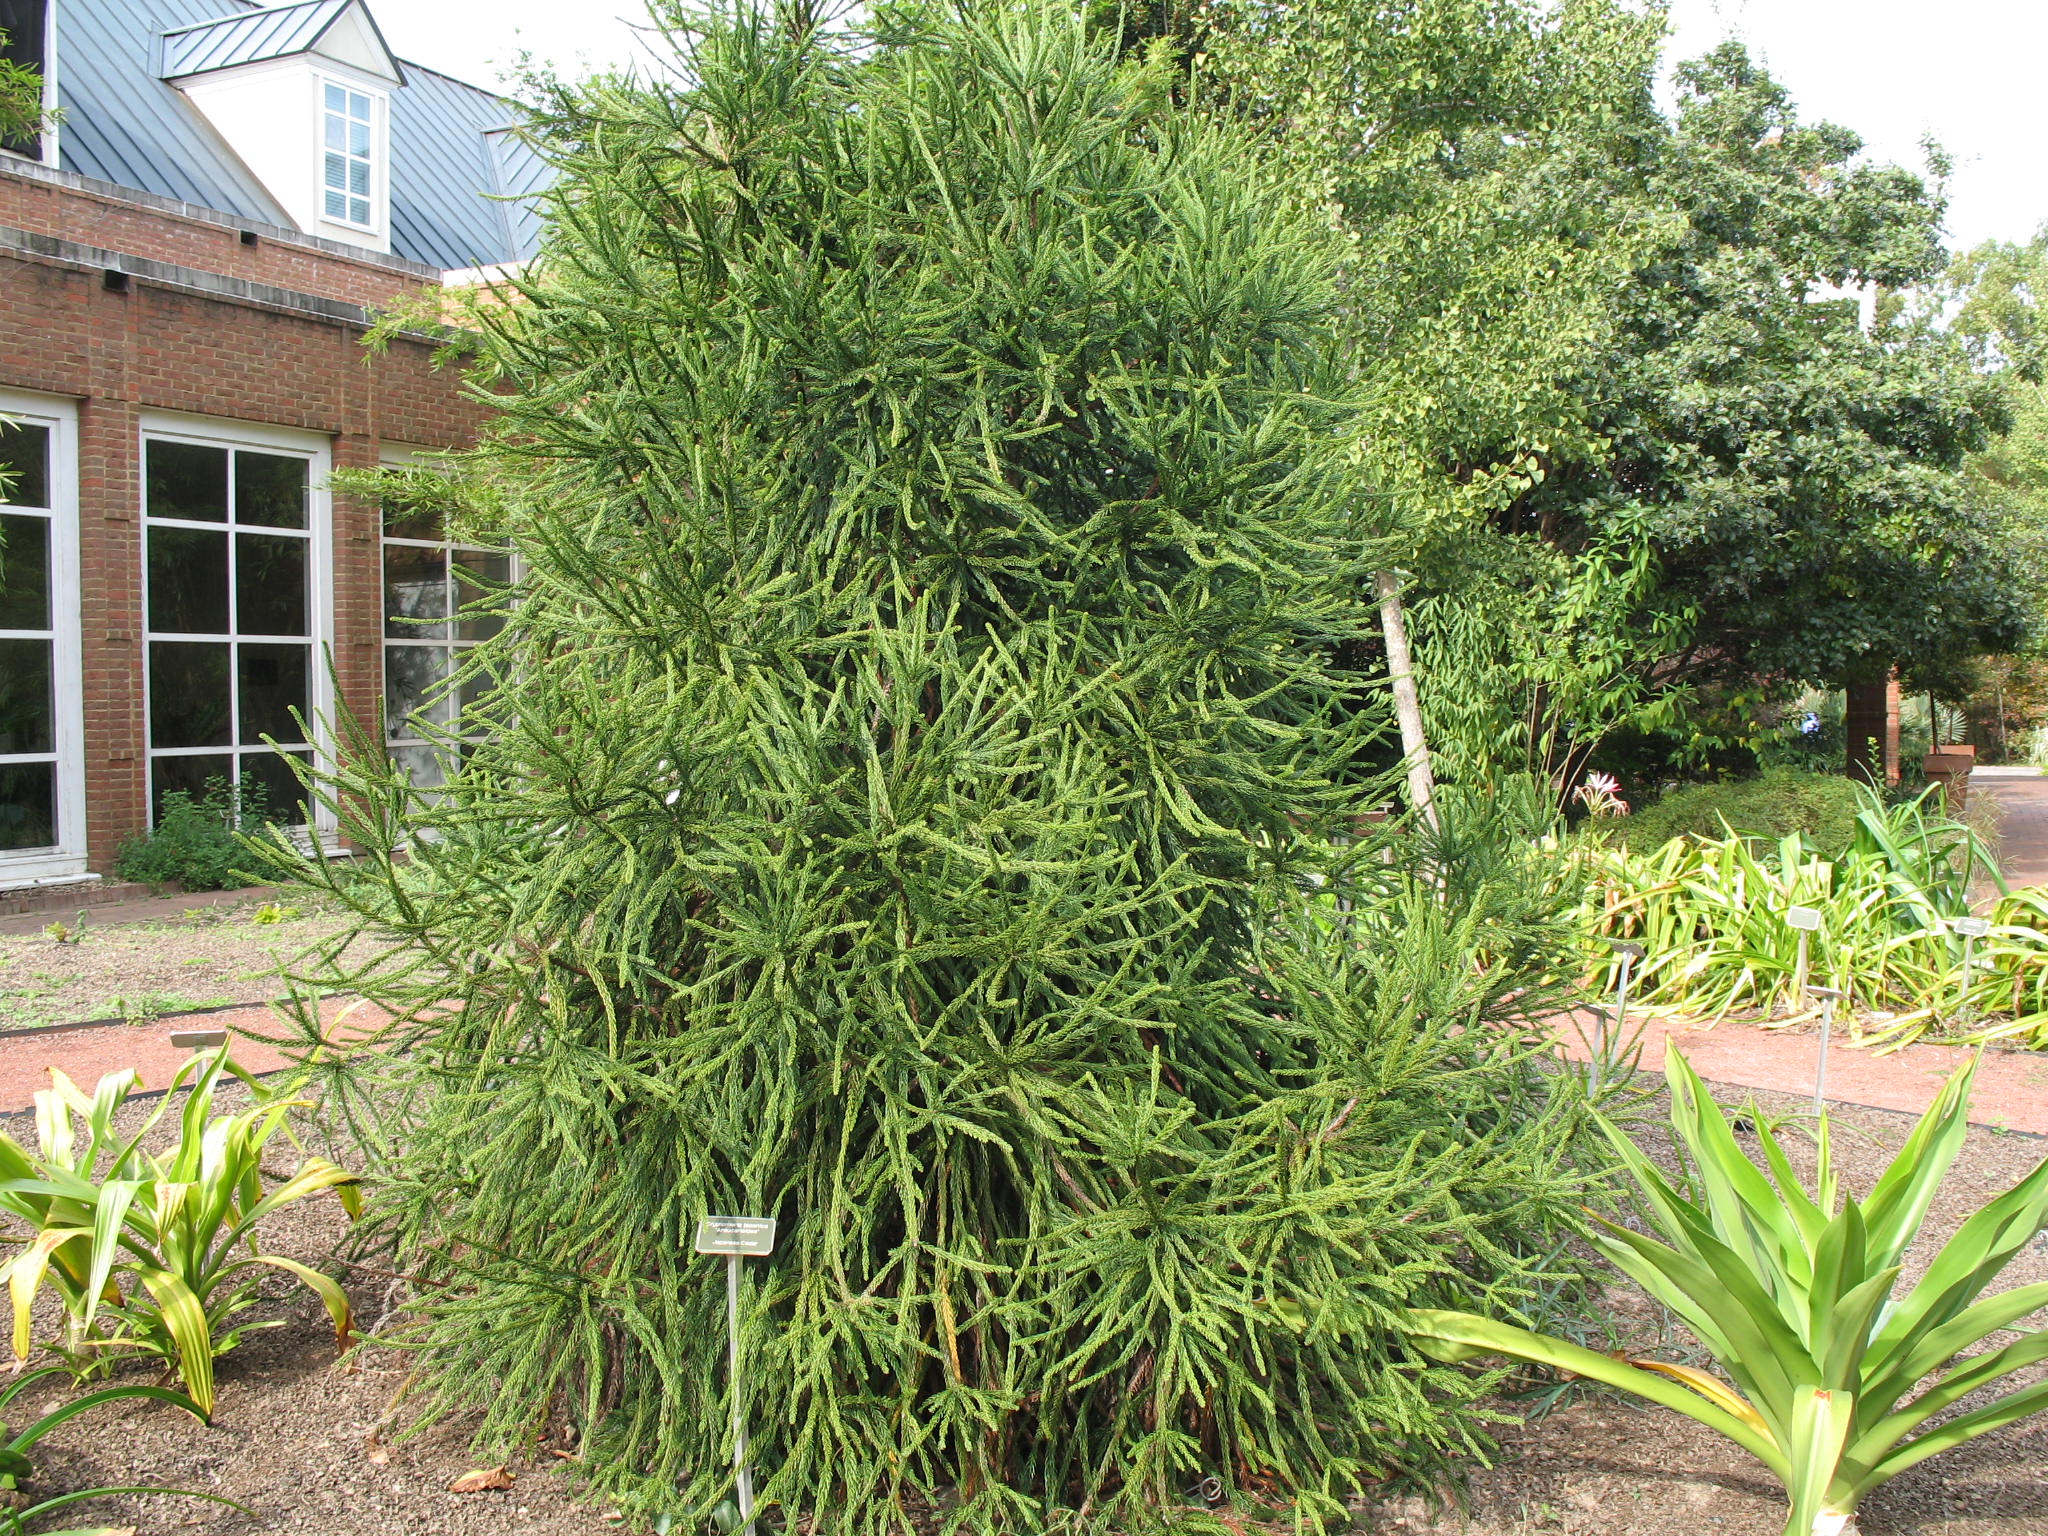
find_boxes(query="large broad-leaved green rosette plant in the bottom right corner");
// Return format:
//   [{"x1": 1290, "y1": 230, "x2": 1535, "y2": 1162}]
[{"x1": 1407, "y1": 1049, "x2": 2048, "y2": 1536}]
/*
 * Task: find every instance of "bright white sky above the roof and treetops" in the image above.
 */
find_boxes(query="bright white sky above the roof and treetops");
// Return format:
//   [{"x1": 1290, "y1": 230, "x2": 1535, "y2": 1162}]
[{"x1": 373, "y1": 0, "x2": 2048, "y2": 246}]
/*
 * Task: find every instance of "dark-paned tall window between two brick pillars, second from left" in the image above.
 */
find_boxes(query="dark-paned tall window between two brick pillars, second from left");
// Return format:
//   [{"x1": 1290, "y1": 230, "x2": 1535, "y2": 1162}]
[{"x1": 143, "y1": 434, "x2": 324, "y2": 823}]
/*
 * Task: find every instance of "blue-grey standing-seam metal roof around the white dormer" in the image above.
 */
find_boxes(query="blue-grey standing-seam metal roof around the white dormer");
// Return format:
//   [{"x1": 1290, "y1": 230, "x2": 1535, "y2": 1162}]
[{"x1": 57, "y1": 0, "x2": 549, "y2": 270}]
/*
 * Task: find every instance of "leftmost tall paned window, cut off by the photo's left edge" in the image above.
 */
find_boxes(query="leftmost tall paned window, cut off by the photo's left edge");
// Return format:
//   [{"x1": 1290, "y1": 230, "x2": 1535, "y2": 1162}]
[{"x1": 0, "y1": 399, "x2": 84, "y2": 881}]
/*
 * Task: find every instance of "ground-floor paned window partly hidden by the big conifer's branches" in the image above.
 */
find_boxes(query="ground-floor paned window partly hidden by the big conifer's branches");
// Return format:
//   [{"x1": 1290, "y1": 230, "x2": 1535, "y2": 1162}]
[{"x1": 383, "y1": 508, "x2": 512, "y2": 788}]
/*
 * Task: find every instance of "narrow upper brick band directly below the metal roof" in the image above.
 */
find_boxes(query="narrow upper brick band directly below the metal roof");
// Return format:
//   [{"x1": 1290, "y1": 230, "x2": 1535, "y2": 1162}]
[{"x1": 0, "y1": 170, "x2": 434, "y2": 305}]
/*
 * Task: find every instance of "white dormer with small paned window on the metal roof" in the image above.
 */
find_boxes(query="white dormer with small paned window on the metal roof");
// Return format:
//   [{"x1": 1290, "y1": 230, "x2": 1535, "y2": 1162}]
[{"x1": 158, "y1": 0, "x2": 406, "y2": 252}]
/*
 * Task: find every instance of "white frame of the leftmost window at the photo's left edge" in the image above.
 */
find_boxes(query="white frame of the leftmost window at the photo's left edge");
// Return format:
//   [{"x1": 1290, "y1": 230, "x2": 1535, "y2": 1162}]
[{"x1": 0, "y1": 389, "x2": 86, "y2": 889}]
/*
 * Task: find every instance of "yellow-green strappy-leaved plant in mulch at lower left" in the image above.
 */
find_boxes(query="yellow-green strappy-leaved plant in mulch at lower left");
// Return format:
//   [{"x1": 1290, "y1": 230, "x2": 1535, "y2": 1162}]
[{"x1": 0, "y1": 1049, "x2": 358, "y2": 1415}]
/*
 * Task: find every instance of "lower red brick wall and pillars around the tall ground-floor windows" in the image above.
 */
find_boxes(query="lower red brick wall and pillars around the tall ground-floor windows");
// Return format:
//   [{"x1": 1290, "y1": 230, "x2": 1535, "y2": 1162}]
[{"x1": 0, "y1": 241, "x2": 483, "y2": 872}]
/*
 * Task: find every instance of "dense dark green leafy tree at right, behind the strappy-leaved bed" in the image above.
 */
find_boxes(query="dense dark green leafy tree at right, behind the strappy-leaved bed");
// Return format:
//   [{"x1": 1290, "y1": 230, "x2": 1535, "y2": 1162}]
[{"x1": 1503, "y1": 43, "x2": 2028, "y2": 774}]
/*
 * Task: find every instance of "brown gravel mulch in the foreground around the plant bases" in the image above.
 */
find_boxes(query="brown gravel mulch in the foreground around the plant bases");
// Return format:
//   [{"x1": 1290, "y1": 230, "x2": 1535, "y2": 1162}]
[{"x1": 6, "y1": 1090, "x2": 2048, "y2": 1536}]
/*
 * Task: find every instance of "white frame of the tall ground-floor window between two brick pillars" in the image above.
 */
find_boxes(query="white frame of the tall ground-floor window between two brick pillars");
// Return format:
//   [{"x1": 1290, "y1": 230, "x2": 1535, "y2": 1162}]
[{"x1": 135, "y1": 412, "x2": 336, "y2": 846}]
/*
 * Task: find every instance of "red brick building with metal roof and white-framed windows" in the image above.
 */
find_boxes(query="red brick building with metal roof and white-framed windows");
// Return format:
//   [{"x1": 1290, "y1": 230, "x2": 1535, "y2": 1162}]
[{"x1": 0, "y1": 0, "x2": 543, "y2": 893}]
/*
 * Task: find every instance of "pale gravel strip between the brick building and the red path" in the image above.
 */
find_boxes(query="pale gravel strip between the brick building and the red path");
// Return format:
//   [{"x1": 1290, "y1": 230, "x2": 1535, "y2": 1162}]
[{"x1": 0, "y1": 897, "x2": 385, "y2": 1030}]
